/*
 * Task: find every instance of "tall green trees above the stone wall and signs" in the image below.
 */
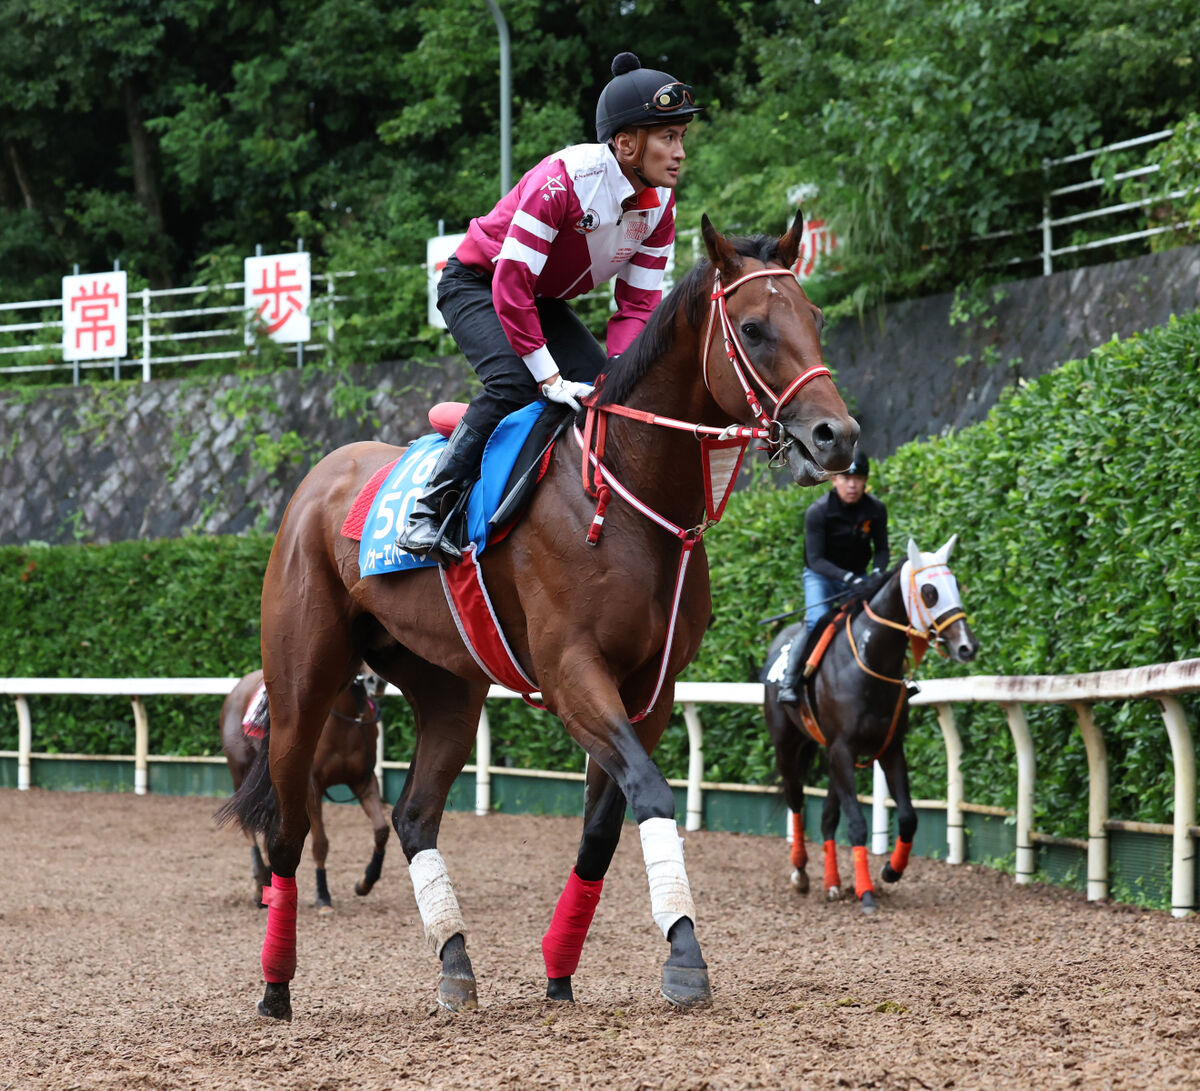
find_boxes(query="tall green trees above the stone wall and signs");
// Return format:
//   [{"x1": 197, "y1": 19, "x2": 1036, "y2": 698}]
[{"x1": 0, "y1": 0, "x2": 1200, "y2": 321}]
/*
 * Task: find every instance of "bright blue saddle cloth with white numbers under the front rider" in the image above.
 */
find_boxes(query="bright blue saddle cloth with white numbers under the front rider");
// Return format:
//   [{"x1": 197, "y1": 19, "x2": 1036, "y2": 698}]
[{"x1": 359, "y1": 400, "x2": 546, "y2": 576}]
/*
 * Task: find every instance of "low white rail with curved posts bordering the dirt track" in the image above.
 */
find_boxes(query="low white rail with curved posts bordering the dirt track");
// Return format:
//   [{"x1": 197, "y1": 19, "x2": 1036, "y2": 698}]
[{"x1": 0, "y1": 659, "x2": 1200, "y2": 916}]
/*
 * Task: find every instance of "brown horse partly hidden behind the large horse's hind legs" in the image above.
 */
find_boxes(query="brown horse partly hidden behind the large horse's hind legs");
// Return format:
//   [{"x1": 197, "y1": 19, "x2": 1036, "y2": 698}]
[{"x1": 221, "y1": 669, "x2": 389, "y2": 915}]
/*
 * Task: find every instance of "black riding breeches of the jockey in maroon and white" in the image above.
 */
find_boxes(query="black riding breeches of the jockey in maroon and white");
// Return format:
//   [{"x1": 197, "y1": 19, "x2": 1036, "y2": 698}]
[{"x1": 438, "y1": 258, "x2": 607, "y2": 436}]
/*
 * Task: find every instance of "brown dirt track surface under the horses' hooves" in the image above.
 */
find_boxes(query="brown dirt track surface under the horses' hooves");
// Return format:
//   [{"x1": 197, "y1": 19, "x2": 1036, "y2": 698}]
[{"x1": 0, "y1": 790, "x2": 1200, "y2": 1091}]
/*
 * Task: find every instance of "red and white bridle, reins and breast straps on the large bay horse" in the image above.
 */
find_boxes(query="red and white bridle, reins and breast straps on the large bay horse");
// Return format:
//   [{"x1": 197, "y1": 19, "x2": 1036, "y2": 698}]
[{"x1": 572, "y1": 262, "x2": 829, "y2": 724}]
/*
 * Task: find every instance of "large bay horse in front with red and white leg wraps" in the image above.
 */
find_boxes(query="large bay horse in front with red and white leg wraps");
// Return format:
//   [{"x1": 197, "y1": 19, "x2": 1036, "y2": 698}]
[{"x1": 218, "y1": 215, "x2": 858, "y2": 1019}]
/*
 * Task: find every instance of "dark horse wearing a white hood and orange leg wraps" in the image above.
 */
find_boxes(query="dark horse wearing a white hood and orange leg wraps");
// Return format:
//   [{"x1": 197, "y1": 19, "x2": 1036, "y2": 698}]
[{"x1": 763, "y1": 534, "x2": 979, "y2": 913}]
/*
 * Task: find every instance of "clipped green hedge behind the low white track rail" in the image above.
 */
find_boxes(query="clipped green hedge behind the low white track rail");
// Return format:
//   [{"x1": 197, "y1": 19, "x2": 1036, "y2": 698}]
[{"x1": 0, "y1": 314, "x2": 1200, "y2": 835}]
